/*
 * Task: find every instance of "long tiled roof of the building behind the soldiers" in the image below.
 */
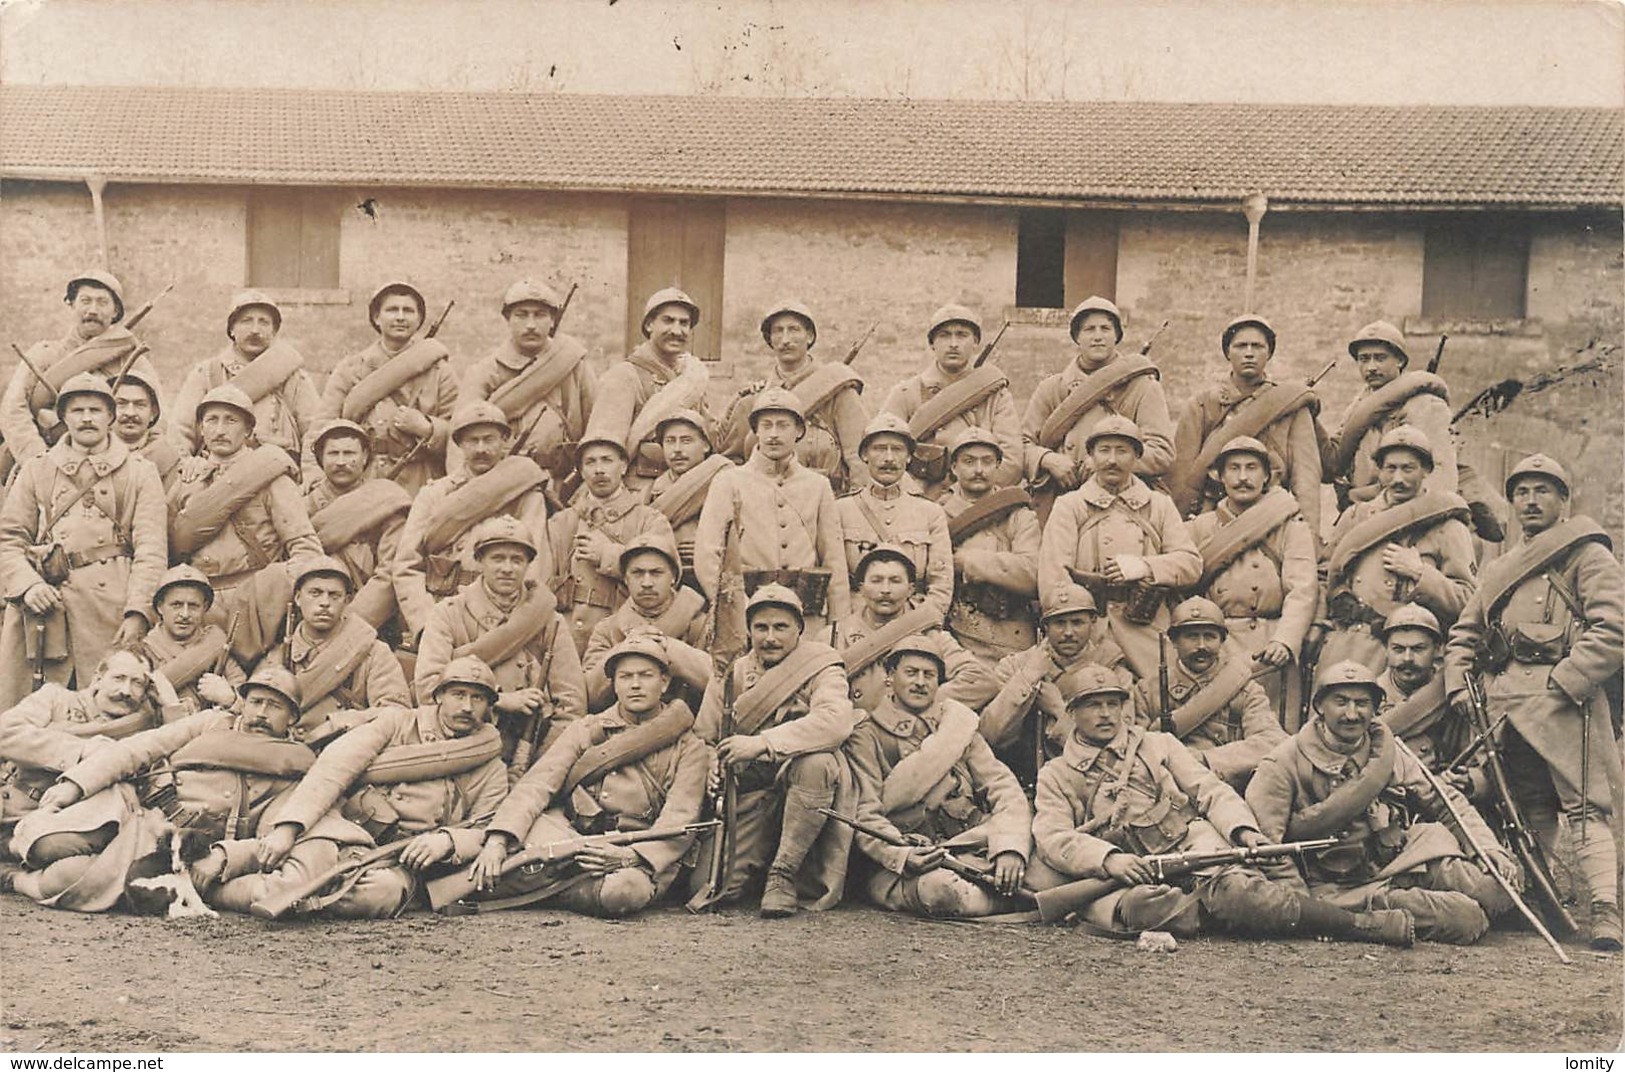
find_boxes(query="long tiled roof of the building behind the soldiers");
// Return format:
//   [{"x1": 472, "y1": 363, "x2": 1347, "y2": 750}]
[{"x1": 0, "y1": 86, "x2": 1625, "y2": 208}]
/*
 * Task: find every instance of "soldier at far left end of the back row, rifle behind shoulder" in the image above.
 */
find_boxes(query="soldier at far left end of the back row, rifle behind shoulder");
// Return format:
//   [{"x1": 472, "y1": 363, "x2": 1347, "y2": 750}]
[{"x1": 0, "y1": 271, "x2": 163, "y2": 465}]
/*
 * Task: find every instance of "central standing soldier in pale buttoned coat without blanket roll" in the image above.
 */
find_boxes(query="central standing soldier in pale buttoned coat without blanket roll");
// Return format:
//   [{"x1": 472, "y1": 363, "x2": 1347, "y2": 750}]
[{"x1": 694, "y1": 388, "x2": 852, "y2": 637}]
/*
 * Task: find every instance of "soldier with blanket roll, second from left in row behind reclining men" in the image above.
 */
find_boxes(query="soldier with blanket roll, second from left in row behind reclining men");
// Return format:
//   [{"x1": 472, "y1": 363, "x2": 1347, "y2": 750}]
[{"x1": 260, "y1": 555, "x2": 411, "y2": 750}]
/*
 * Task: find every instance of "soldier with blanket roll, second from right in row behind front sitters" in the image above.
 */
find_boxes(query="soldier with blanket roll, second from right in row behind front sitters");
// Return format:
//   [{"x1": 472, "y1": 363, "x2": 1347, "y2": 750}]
[{"x1": 1134, "y1": 596, "x2": 1287, "y2": 791}]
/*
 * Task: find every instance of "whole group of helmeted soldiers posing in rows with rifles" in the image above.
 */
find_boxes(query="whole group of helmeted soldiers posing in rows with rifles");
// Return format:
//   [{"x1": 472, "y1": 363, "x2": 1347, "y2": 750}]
[{"x1": 0, "y1": 271, "x2": 1625, "y2": 950}]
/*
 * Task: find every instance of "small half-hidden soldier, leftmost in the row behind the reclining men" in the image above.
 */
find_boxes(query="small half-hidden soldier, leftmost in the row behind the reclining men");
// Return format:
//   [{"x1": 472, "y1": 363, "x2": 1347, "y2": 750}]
[{"x1": 143, "y1": 564, "x2": 247, "y2": 715}]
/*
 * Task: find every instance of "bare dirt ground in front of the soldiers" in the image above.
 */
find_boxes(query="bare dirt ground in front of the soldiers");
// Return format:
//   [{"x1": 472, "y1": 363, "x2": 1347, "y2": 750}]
[{"x1": 0, "y1": 895, "x2": 1622, "y2": 1053}]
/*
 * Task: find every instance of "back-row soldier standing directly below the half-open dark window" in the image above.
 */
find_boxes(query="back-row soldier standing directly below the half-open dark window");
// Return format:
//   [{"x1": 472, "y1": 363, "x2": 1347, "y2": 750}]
[{"x1": 1021, "y1": 296, "x2": 1173, "y2": 518}]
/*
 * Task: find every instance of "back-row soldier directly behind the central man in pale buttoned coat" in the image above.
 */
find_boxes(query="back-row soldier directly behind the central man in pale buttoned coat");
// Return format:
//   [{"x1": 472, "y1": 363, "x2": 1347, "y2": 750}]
[{"x1": 723, "y1": 299, "x2": 869, "y2": 495}]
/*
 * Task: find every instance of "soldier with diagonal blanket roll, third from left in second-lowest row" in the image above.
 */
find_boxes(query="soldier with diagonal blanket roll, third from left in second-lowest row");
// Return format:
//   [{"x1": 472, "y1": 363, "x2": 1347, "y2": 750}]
[{"x1": 413, "y1": 517, "x2": 587, "y2": 778}]
